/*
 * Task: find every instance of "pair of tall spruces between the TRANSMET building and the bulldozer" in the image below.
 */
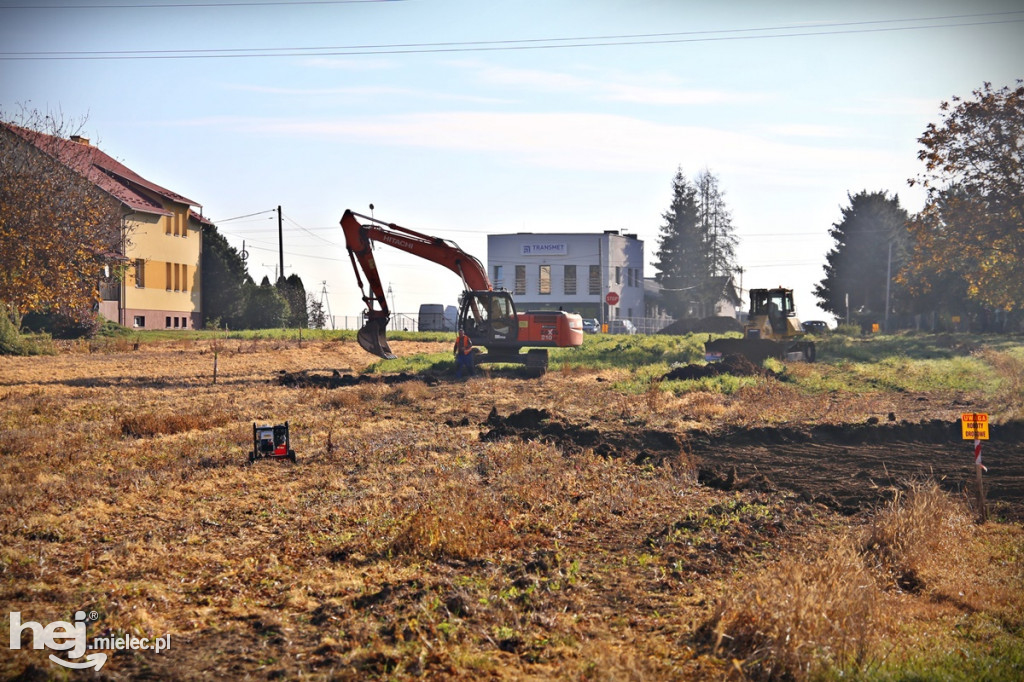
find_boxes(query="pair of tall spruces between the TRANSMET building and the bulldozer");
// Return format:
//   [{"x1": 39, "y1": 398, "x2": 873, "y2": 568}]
[{"x1": 654, "y1": 169, "x2": 736, "y2": 317}]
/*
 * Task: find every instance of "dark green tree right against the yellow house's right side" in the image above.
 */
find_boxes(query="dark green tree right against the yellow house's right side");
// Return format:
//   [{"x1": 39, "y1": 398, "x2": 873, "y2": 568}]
[{"x1": 200, "y1": 225, "x2": 253, "y2": 329}]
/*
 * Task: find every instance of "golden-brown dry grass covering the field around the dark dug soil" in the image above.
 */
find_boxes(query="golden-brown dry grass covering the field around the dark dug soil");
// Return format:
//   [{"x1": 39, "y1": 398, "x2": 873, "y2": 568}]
[{"x1": 0, "y1": 341, "x2": 1024, "y2": 680}]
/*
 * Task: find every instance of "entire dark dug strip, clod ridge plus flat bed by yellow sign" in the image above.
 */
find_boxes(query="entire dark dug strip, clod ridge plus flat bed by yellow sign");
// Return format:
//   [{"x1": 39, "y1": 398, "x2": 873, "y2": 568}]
[{"x1": 479, "y1": 408, "x2": 1024, "y2": 521}]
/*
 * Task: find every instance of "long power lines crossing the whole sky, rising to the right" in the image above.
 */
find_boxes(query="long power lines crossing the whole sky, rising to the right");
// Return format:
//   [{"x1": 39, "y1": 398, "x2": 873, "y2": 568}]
[{"x1": 0, "y1": 11, "x2": 1024, "y2": 60}]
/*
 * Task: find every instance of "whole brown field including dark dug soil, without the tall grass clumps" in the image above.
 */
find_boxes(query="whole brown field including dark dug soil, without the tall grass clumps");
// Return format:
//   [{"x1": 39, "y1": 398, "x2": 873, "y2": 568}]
[{"x1": 0, "y1": 340, "x2": 1024, "y2": 679}]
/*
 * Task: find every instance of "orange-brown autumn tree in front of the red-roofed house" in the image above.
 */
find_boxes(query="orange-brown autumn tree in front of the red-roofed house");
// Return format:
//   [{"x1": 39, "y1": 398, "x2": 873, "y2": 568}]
[{"x1": 0, "y1": 112, "x2": 127, "y2": 324}]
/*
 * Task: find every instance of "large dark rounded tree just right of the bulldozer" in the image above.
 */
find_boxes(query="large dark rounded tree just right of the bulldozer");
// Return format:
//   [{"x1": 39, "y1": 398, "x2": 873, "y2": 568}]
[{"x1": 814, "y1": 190, "x2": 907, "y2": 317}]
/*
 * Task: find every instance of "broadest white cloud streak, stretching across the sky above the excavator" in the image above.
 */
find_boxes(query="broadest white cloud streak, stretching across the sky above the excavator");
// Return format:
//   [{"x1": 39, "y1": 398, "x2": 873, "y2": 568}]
[{"x1": 176, "y1": 112, "x2": 902, "y2": 186}]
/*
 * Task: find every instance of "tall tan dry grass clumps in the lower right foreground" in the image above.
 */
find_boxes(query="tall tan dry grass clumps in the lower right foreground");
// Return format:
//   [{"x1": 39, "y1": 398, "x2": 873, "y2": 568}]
[{"x1": 707, "y1": 481, "x2": 978, "y2": 679}]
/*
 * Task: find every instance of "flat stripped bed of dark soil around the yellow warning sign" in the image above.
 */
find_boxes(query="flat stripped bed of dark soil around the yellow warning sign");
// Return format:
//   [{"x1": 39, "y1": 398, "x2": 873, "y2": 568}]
[{"x1": 687, "y1": 420, "x2": 1024, "y2": 521}]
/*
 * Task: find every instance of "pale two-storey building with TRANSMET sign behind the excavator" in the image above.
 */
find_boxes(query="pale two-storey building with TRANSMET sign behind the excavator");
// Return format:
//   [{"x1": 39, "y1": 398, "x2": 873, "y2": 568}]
[{"x1": 487, "y1": 230, "x2": 644, "y2": 322}]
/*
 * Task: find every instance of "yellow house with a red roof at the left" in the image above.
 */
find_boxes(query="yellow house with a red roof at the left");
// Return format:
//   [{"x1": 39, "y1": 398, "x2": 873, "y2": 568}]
[{"x1": 0, "y1": 123, "x2": 212, "y2": 329}]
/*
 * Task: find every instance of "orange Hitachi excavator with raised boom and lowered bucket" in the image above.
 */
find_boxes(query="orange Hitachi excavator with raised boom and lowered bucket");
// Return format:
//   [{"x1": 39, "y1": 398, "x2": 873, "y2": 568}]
[{"x1": 341, "y1": 210, "x2": 583, "y2": 373}]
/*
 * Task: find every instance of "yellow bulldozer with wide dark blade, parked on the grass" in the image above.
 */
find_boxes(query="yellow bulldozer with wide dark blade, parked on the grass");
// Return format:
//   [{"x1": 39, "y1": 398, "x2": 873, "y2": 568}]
[{"x1": 705, "y1": 287, "x2": 815, "y2": 365}]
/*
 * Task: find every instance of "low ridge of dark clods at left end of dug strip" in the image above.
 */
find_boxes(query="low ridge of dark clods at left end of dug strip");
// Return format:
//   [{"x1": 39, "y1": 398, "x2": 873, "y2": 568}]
[{"x1": 480, "y1": 408, "x2": 683, "y2": 464}]
